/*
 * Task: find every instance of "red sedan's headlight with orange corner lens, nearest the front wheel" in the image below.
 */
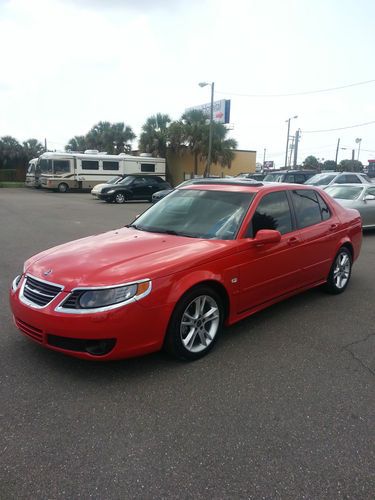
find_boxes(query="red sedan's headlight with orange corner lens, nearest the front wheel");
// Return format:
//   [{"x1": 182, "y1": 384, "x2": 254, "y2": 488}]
[{"x1": 56, "y1": 280, "x2": 151, "y2": 313}]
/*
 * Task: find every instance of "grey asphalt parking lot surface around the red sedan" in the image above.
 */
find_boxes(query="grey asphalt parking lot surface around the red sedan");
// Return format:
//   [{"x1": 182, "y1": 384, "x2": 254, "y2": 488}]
[{"x1": 0, "y1": 189, "x2": 375, "y2": 499}]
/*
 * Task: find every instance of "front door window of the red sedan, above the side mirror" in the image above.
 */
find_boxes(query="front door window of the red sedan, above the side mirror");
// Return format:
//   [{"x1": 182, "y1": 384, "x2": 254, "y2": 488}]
[{"x1": 247, "y1": 191, "x2": 292, "y2": 238}]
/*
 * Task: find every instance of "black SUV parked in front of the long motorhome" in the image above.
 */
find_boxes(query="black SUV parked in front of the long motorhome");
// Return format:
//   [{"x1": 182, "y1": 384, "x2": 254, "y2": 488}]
[{"x1": 98, "y1": 174, "x2": 171, "y2": 203}]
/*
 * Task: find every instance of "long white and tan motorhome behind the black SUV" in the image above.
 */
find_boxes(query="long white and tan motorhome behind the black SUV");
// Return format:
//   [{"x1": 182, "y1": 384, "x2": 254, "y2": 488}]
[{"x1": 36, "y1": 150, "x2": 165, "y2": 193}]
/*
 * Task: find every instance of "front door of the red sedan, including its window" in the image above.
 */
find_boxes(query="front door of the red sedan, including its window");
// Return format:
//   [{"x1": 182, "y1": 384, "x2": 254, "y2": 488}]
[{"x1": 237, "y1": 190, "x2": 301, "y2": 314}]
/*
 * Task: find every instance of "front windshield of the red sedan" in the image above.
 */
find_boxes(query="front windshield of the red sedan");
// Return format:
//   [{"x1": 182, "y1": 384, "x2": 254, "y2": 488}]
[{"x1": 130, "y1": 189, "x2": 254, "y2": 240}]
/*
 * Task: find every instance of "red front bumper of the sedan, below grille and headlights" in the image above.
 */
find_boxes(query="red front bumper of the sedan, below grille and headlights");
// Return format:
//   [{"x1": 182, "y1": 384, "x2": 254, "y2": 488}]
[{"x1": 10, "y1": 287, "x2": 169, "y2": 360}]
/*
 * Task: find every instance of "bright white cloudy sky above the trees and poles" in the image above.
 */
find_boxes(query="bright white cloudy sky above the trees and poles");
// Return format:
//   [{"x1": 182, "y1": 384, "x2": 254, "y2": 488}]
[{"x1": 0, "y1": 0, "x2": 375, "y2": 165}]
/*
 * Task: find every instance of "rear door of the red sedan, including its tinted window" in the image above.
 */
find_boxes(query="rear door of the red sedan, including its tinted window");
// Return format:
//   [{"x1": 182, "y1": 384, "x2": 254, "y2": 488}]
[{"x1": 289, "y1": 189, "x2": 340, "y2": 285}]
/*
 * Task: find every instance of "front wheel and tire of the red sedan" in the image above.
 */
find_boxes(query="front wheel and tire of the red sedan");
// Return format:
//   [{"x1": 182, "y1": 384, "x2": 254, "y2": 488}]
[{"x1": 164, "y1": 285, "x2": 224, "y2": 361}]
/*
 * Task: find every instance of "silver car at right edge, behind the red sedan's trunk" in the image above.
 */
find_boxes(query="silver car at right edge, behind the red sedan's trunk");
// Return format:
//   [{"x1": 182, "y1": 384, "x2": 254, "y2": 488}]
[{"x1": 325, "y1": 184, "x2": 375, "y2": 229}]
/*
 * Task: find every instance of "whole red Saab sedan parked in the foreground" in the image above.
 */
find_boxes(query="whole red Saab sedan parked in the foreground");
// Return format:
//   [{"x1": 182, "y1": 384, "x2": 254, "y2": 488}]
[{"x1": 10, "y1": 179, "x2": 362, "y2": 360}]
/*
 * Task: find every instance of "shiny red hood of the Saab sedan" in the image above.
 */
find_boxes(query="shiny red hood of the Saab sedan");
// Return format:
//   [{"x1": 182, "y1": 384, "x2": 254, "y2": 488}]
[{"x1": 25, "y1": 228, "x2": 235, "y2": 291}]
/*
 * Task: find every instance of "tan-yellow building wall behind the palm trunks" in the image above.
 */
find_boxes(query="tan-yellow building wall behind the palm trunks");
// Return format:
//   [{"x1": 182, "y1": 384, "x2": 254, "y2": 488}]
[{"x1": 167, "y1": 149, "x2": 256, "y2": 186}]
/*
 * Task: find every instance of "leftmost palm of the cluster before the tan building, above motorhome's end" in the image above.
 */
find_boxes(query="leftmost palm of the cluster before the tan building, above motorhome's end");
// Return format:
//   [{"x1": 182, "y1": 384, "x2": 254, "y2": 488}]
[{"x1": 139, "y1": 113, "x2": 172, "y2": 158}]
